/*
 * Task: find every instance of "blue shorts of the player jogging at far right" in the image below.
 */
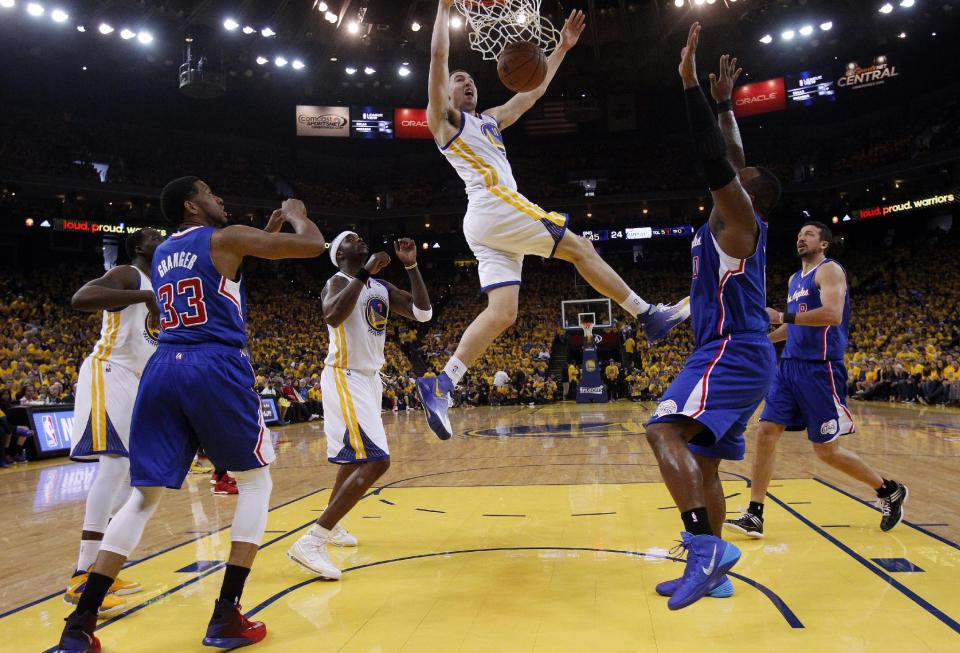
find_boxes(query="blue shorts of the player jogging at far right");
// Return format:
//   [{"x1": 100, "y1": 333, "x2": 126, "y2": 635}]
[{"x1": 760, "y1": 358, "x2": 857, "y2": 444}]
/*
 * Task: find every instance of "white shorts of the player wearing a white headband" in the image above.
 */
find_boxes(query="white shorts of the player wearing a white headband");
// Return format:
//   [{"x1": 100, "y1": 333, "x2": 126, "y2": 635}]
[{"x1": 320, "y1": 365, "x2": 390, "y2": 464}]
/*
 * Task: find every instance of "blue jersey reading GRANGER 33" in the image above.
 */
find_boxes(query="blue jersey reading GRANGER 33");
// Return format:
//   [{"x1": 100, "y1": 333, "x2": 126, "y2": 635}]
[{"x1": 152, "y1": 227, "x2": 247, "y2": 348}]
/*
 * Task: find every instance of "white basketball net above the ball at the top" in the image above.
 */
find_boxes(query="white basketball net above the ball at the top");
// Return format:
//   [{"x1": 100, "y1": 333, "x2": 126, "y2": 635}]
[{"x1": 454, "y1": 0, "x2": 560, "y2": 61}]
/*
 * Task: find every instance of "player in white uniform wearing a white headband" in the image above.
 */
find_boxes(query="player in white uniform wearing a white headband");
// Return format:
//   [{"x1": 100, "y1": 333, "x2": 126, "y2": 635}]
[{"x1": 287, "y1": 231, "x2": 433, "y2": 580}]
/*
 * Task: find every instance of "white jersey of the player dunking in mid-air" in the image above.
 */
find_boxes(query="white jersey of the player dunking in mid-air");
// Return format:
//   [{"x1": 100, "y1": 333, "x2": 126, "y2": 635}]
[{"x1": 440, "y1": 111, "x2": 517, "y2": 199}]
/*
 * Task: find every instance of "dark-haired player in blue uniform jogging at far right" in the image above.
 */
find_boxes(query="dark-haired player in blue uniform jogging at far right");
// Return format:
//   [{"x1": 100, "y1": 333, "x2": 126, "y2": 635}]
[{"x1": 725, "y1": 222, "x2": 907, "y2": 537}]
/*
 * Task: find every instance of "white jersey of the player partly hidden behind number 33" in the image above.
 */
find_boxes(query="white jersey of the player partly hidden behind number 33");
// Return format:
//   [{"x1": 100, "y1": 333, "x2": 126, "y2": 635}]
[{"x1": 91, "y1": 267, "x2": 159, "y2": 376}]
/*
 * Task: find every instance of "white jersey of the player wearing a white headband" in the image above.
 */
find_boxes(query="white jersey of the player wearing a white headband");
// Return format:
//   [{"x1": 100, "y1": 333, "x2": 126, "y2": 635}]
[{"x1": 325, "y1": 272, "x2": 390, "y2": 374}]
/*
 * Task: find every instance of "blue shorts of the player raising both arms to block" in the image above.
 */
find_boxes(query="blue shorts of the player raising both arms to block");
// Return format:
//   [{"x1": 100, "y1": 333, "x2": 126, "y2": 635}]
[{"x1": 647, "y1": 333, "x2": 777, "y2": 460}]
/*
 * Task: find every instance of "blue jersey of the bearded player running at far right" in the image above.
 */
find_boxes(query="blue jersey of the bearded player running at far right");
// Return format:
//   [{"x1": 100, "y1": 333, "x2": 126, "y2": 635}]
[{"x1": 783, "y1": 258, "x2": 850, "y2": 361}]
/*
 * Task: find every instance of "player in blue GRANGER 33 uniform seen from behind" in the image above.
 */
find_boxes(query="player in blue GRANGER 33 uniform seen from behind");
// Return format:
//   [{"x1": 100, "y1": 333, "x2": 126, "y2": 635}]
[{"x1": 59, "y1": 177, "x2": 324, "y2": 653}]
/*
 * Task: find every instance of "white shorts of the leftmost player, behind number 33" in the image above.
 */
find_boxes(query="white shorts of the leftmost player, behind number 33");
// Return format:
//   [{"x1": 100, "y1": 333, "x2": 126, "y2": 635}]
[{"x1": 70, "y1": 356, "x2": 140, "y2": 461}]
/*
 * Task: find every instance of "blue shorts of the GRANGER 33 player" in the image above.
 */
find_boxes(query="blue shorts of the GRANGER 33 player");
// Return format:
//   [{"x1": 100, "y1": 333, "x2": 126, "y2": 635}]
[{"x1": 130, "y1": 344, "x2": 276, "y2": 489}]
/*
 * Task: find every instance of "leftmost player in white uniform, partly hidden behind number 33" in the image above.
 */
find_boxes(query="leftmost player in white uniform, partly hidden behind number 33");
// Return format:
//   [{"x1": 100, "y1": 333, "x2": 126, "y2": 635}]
[{"x1": 64, "y1": 229, "x2": 163, "y2": 617}]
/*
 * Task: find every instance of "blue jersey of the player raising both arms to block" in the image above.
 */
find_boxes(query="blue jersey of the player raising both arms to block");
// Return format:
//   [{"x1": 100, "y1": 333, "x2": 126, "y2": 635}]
[{"x1": 690, "y1": 216, "x2": 770, "y2": 347}]
